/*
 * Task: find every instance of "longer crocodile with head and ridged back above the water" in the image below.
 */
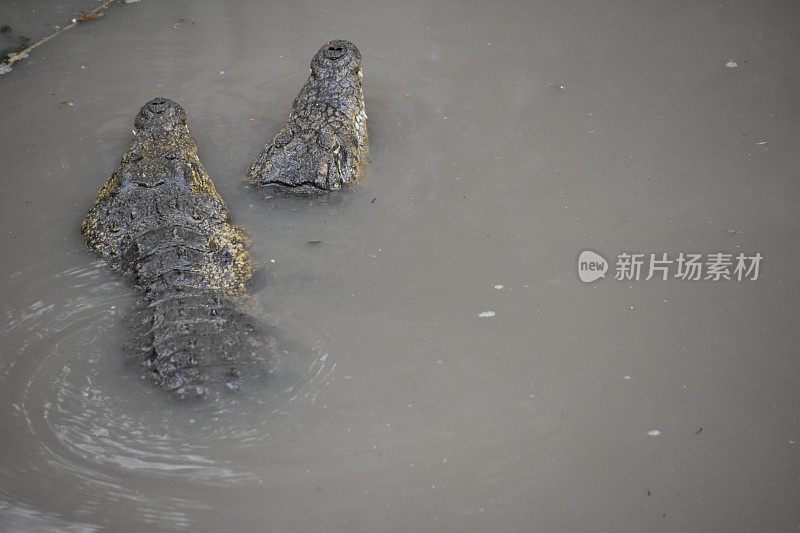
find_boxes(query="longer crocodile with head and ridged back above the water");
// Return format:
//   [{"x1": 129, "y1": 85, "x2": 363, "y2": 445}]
[{"x1": 81, "y1": 98, "x2": 274, "y2": 398}]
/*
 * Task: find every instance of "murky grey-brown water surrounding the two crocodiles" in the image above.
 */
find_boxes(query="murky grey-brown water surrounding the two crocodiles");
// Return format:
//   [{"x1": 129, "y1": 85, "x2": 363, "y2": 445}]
[{"x1": 0, "y1": 0, "x2": 800, "y2": 531}]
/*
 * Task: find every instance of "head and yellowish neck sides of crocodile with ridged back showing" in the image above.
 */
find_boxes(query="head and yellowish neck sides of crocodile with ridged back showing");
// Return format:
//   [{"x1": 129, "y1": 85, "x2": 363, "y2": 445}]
[{"x1": 82, "y1": 98, "x2": 252, "y2": 290}]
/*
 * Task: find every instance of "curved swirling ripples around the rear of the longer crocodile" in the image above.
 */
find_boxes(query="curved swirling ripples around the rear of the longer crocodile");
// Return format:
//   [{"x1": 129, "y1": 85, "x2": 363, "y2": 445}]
[{"x1": 0, "y1": 263, "x2": 336, "y2": 528}]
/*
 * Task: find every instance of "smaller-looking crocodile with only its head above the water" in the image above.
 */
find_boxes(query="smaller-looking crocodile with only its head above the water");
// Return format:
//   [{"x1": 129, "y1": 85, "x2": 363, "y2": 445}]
[{"x1": 247, "y1": 40, "x2": 369, "y2": 193}]
